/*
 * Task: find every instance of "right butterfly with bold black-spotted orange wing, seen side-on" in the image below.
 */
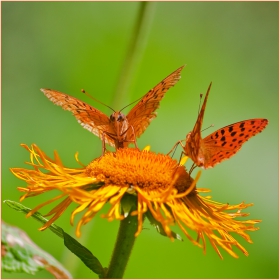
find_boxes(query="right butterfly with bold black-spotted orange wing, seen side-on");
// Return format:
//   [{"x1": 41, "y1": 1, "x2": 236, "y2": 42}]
[{"x1": 181, "y1": 83, "x2": 268, "y2": 172}]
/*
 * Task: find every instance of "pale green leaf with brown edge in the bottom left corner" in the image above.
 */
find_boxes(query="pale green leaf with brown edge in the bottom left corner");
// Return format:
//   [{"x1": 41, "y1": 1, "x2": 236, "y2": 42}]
[{"x1": 1, "y1": 222, "x2": 72, "y2": 279}]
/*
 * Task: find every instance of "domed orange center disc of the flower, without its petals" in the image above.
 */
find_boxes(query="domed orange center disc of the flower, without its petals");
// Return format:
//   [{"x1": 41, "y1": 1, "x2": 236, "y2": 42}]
[{"x1": 85, "y1": 148, "x2": 193, "y2": 193}]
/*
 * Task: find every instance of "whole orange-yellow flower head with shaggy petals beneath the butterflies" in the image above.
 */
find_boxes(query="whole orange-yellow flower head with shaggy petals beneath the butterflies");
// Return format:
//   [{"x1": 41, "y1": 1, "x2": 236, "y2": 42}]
[{"x1": 11, "y1": 145, "x2": 260, "y2": 258}]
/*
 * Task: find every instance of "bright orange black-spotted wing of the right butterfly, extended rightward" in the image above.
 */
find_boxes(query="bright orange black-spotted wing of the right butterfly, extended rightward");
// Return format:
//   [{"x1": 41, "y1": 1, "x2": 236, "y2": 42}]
[{"x1": 202, "y1": 119, "x2": 268, "y2": 168}]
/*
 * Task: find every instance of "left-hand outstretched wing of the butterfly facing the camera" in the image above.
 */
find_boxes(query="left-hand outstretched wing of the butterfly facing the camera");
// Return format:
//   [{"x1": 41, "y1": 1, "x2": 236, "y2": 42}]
[{"x1": 41, "y1": 89, "x2": 114, "y2": 146}]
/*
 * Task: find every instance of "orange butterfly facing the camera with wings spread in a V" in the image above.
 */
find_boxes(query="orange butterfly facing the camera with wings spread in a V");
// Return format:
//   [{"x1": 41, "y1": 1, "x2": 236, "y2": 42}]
[{"x1": 41, "y1": 65, "x2": 185, "y2": 154}]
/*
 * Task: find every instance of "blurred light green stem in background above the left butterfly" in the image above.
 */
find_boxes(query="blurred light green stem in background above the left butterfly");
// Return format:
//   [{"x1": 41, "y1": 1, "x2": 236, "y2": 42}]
[{"x1": 113, "y1": 1, "x2": 156, "y2": 110}]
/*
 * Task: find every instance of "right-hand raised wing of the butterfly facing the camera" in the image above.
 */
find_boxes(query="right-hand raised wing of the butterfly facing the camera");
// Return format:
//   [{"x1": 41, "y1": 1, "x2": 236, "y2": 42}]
[{"x1": 127, "y1": 66, "x2": 185, "y2": 140}]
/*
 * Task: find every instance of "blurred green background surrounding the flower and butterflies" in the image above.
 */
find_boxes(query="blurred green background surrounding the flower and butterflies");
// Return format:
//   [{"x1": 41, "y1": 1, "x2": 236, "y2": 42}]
[{"x1": 1, "y1": 2, "x2": 279, "y2": 278}]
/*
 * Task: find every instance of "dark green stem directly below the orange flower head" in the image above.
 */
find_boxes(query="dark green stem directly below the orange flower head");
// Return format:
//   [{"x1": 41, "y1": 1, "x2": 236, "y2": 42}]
[{"x1": 106, "y1": 215, "x2": 138, "y2": 279}]
